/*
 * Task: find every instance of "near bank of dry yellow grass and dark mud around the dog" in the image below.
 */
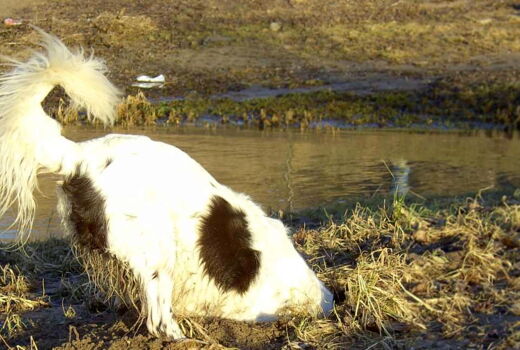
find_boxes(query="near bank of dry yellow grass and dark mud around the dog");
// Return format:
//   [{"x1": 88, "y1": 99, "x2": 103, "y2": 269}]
[{"x1": 0, "y1": 198, "x2": 520, "y2": 349}]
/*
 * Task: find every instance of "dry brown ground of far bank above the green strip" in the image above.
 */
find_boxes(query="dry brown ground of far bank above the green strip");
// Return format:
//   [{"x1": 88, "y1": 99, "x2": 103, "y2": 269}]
[{"x1": 0, "y1": 0, "x2": 520, "y2": 100}]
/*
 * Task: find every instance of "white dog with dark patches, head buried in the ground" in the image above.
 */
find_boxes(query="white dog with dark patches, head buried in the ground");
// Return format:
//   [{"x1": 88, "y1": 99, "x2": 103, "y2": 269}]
[{"x1": 0, "y1": 29, "x2": 333, "y2": 339}]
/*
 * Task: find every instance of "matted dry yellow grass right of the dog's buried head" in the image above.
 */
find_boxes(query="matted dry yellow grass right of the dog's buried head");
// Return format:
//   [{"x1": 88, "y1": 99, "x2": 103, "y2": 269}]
[{"x1": 294, "y1": 196, "x2": 520, "y2": 344}]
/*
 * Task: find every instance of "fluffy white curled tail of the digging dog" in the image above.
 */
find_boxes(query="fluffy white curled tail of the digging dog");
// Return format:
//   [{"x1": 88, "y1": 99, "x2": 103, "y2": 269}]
[{"x1": 0, "y1": 28, "x2": 119, "y2": 238}]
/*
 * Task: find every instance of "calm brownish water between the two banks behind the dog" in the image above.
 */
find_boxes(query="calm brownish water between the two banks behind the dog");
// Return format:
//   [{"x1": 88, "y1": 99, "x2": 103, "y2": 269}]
[{"x1": 0, "y1": 127, "x2": 520, "y2": 238}]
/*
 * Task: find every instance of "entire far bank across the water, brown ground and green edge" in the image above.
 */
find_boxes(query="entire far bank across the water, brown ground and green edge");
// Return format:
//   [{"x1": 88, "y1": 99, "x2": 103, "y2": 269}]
[{"x1": 7, "y1": 0, "x2": 520, "y2": 129}]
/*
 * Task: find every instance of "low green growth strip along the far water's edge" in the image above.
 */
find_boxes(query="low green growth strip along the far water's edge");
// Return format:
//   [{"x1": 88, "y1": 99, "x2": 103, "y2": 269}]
[{"x1": 54, "y1": 77, "x2": 520, "y2": 130}]
